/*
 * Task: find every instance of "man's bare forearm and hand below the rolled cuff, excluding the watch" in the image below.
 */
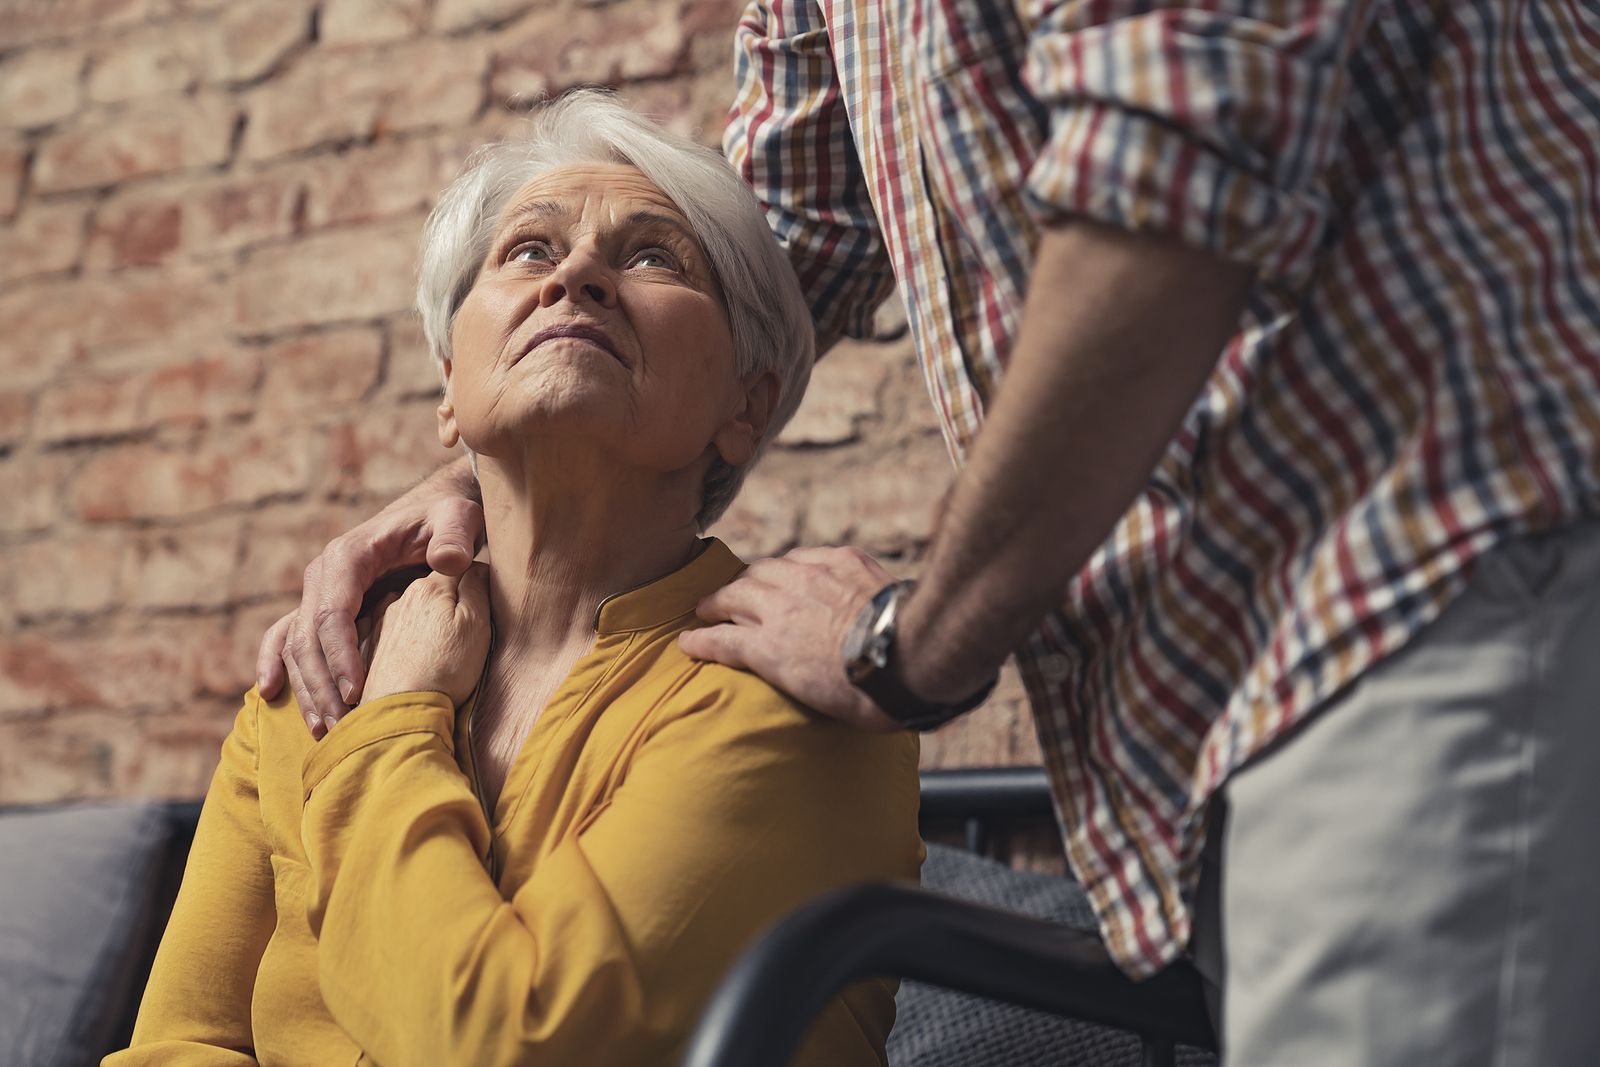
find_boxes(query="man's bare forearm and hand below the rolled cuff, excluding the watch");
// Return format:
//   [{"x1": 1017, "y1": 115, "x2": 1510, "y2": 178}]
[{"x1": 680, "y1": 222, "x2": 1251, "y2": 728}]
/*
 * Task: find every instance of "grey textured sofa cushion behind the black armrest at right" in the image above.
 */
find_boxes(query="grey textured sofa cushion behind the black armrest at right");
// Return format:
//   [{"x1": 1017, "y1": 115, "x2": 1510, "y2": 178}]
[{"x1": 890, "y1": 845, "x2": 1216, "y2": 1067}]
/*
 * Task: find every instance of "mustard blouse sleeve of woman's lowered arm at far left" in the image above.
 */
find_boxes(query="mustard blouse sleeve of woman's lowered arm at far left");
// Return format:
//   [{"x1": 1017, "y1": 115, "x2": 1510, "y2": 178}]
[{"x1": 104, "y1": 693, "x2": 277, "y2": 1067}]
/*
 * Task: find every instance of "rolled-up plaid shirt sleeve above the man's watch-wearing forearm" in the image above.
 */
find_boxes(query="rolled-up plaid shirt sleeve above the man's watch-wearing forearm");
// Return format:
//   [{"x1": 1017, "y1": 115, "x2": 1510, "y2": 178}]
[{"x1": 1024, "y1": 0, "x2": 1374, "y2": 285}]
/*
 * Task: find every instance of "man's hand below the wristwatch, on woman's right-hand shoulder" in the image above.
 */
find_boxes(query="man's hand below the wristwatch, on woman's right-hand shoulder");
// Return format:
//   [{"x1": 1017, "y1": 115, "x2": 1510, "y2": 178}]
[{"x1": 678, "y1": 549, "x2": 901, "y2": 733}]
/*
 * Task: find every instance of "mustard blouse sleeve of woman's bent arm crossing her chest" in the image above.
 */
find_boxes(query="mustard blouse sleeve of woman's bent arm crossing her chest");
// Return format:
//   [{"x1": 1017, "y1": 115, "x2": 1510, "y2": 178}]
[{"x1": 302, "y1": 686, "x2": 920, "y2": 1067}]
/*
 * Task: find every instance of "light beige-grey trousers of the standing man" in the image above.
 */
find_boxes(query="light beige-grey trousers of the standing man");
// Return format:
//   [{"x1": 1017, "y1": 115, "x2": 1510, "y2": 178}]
[{"x1": 1192, "y1": 522, "x2": 1600, "y2": 1067}]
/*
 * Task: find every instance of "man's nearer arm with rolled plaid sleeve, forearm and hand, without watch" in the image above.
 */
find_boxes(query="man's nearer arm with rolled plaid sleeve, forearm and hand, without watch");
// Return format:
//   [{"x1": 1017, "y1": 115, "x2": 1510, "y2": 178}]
[{"x1": 683, "y1": 0, "x2": 1374, "y2": 728}]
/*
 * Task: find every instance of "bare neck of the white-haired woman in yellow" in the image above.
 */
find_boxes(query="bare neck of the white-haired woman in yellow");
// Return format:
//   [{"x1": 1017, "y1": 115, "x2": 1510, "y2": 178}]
[{"x1": 478, "y1": 444, "x2": 698, "y2": 659}]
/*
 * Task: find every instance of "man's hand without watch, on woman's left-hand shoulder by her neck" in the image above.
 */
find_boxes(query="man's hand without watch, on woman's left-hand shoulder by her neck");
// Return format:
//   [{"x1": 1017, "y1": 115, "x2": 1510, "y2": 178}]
[{"x1": 256, "y1": 461, "x2": 483, "y2": 737}]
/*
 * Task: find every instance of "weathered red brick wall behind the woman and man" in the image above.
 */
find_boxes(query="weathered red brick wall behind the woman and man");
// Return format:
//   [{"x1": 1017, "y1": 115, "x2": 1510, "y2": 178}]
[{"x1": 0, "y1": 0, "x2": 1035, "y2": 803}]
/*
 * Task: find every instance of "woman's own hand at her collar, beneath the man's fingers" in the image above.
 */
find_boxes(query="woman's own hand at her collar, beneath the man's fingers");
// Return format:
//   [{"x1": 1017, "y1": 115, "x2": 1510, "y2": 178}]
[{"x1": 363, "y1": 563, "x2": 490, "y2": 707}]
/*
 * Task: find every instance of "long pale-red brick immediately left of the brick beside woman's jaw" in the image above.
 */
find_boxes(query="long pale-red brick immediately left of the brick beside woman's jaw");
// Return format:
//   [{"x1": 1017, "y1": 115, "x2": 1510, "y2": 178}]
[{"x1": 70, "y1": 429, "x2": 312, "y2": 522}]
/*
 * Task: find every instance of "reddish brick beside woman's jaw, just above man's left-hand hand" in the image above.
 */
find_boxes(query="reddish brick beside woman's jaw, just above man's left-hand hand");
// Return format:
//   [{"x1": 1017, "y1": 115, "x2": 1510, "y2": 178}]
[{"x1": 325, "y1": 402, "x2": 461, "y2": 496}]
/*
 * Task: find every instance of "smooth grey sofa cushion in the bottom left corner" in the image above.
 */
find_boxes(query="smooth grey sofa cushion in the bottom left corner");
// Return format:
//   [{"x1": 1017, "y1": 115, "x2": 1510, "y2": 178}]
[{"x1": 0, "y1": 803, "x2": 173, "y2": 1067}]
